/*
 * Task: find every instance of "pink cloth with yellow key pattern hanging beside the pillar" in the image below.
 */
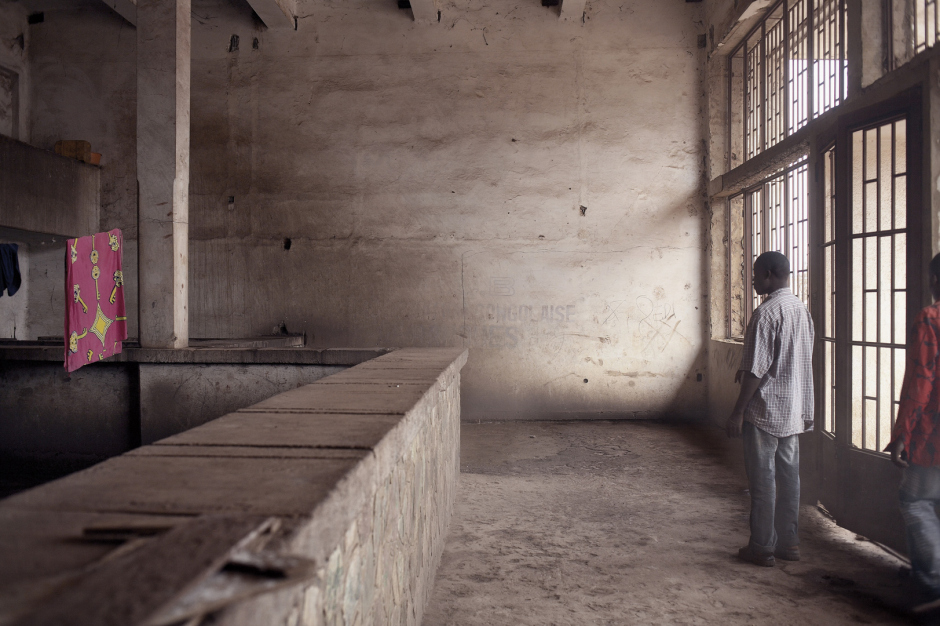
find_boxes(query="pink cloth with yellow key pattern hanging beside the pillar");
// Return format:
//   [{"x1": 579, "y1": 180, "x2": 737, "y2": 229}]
[{"x1": 65, "y1": 228, "x2": 127, "y2": 372}]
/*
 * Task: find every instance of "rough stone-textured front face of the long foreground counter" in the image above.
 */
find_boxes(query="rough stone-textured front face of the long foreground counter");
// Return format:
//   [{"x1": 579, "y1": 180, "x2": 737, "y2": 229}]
[{"x1": 298, "y1": 379, "x2": 460, "y2": 626}]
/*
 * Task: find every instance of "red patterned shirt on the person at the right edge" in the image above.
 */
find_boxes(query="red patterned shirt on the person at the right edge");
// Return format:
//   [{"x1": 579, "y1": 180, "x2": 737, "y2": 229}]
[{"x1": 891, "y1": 303, "x2": 940, "y2": 467}]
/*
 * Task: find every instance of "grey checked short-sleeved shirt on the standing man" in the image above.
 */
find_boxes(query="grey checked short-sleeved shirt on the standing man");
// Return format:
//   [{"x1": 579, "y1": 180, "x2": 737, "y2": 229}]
[{"x1": 739, "y1": 287, "x2": 813, "y2": 437}]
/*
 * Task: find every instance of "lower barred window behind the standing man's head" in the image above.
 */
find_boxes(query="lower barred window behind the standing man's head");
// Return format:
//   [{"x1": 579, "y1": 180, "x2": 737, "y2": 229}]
[{"x1": 728, "y1": 159, "x2": 809, "y2": 338}]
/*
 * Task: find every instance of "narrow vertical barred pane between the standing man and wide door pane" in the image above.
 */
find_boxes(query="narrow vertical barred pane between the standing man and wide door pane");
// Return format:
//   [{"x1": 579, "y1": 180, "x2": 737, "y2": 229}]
[{"x1": 821, "y1": 147, "x2": 836, "y2": 433}]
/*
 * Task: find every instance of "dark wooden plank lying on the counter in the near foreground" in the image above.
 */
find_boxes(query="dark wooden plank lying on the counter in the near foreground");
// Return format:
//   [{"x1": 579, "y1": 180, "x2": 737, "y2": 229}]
[{"x1": 15, "y1": 515, "x2": 272, "y2": 626}]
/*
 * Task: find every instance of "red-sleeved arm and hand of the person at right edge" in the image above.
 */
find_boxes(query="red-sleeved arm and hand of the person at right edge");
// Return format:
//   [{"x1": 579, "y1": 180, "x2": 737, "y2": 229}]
[{"x1": 885, "y1": 313, "x2": 938, "y2": 467}]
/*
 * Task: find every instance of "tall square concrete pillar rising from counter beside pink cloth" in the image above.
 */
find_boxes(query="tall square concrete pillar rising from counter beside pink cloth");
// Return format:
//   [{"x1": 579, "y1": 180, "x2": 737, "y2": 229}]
[{"x1": 137, "y1": 0, "x2": 191, "y2": 348}]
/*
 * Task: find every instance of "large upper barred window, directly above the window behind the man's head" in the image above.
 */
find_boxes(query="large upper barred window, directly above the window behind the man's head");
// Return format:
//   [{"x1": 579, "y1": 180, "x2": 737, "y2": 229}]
[{"x1": 728, "y1": 0, "x2": 848, "y2": 169}]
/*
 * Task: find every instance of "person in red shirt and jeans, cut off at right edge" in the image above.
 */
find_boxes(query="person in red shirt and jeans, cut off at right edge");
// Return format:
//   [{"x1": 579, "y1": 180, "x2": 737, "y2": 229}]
[{"x1": 885, "y1": 254, "x2": 940, "y2": 612}]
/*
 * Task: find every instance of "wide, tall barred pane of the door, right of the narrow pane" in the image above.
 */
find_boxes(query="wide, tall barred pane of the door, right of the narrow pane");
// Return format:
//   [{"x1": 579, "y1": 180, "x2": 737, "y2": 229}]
[{"x1": 849, "y1": 119, "x2": 907, "y2": 451}]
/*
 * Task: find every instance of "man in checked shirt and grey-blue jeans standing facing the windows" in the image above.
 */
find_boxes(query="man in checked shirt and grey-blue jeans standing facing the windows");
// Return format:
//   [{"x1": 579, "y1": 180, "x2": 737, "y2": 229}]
[{"x1": 728, "y1": 252, "x2": 813, "y2": 567}]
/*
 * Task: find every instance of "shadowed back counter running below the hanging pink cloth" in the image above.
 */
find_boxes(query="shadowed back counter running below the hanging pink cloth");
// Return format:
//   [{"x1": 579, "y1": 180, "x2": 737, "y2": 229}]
[{"x1": 0, "y1": 345, "x2": 393, "y2": 462}]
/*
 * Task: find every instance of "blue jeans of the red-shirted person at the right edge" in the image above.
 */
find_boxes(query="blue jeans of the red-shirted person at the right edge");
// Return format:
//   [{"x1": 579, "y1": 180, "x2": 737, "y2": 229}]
[{"x1": 898, "y1": 465, "x2": 940, "y2": 595}]
